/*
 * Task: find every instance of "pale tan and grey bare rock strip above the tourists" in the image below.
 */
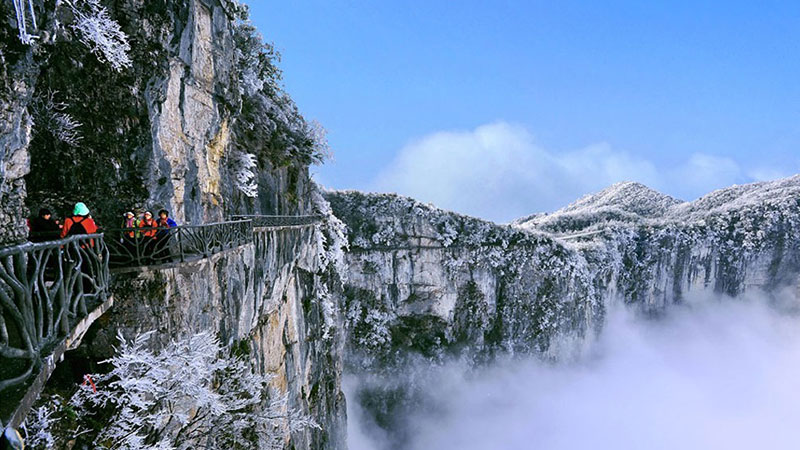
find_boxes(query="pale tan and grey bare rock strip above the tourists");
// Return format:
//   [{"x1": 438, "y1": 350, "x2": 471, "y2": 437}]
[{"x1": 146, "y1": 1, "x2": 239, "y2": 223}]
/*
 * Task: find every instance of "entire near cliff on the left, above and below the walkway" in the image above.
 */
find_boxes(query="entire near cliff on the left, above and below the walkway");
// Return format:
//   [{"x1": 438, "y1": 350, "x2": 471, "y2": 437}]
[{"x1": 0, "y1": 0, "x2": 345, "y2": 448}]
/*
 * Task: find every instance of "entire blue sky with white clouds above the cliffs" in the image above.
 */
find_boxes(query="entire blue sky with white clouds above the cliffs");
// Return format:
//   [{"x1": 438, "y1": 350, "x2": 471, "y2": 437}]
[{"x1": 248, "y1": 0, "x2": 800, "y2": 221}]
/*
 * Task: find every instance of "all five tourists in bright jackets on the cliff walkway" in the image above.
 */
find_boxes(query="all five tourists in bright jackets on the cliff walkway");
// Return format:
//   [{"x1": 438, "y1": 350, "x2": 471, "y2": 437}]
[{"x1": 28, "y1": 202, "x2": 178, "y2": 260}]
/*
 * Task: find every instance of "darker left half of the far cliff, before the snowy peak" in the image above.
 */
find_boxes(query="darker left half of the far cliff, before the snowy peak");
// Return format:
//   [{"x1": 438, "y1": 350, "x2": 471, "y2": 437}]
[{"x1": 327, "y1": 192, "x2": 604, "y2": 369}]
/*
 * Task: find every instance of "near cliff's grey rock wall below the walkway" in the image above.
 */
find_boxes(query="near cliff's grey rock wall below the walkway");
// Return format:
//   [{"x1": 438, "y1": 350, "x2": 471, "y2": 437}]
[{"x1": 81, "y1": 226, "x2": 346, "y2": 449}]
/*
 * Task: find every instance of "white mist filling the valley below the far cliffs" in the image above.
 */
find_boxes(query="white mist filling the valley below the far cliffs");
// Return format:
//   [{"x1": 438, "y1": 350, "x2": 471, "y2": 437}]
[{"x1": 348, "y1": 299, "x2": 800, "y2": 450}]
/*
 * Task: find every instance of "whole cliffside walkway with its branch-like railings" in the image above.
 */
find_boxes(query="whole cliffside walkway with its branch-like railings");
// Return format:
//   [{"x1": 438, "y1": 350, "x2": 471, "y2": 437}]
[{"x1": 0, "y1": 215, "x2": 323, "y2": 440}]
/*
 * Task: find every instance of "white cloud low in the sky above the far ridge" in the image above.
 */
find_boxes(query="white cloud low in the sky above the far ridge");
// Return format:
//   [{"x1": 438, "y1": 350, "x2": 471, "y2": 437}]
[{"x1": 372, "y1": 122, "x2": 797, "y2": 222}]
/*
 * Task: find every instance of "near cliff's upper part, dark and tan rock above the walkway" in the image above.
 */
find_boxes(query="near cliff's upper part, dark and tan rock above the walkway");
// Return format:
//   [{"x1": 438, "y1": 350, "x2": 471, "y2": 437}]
[{"x1": 7, "y1": 0, "x2": 317, "y2": 227}]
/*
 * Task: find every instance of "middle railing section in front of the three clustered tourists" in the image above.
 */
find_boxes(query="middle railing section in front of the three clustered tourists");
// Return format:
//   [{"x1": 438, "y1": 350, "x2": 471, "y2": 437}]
[{"x1": 104, "y1": 220, "x2": 253, "y2": 268}]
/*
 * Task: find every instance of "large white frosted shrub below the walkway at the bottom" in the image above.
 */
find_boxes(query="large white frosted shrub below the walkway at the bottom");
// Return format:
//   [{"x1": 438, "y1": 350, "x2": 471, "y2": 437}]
[{"x1": 25, "y1": 333, "x2": 318, "y2": 450}]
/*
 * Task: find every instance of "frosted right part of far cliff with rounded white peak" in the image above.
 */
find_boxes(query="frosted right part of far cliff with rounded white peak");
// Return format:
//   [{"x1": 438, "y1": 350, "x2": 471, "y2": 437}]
[{"x1": 518, "y1": 176, "x2": 800, "y2": 313}]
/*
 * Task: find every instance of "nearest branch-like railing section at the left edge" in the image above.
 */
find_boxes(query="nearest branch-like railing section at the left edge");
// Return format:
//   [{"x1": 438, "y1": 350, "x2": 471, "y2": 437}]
[{"x1": 0, "y1": 234, "x2": 109, "y2": 420}]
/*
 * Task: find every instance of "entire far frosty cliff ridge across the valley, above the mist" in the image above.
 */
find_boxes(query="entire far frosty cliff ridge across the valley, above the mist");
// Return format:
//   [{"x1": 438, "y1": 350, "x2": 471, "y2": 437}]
[{"x1": 327, "y1": 176, "x2": 800, "y2": 442}]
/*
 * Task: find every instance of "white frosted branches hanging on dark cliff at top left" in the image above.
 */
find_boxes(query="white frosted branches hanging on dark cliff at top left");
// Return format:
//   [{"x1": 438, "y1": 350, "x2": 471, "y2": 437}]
[{"x1": 64, "y1": 0, "x2": 132, "y2": 72}]
